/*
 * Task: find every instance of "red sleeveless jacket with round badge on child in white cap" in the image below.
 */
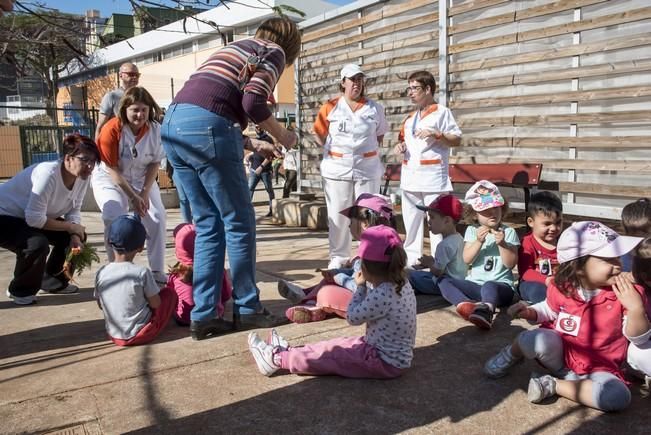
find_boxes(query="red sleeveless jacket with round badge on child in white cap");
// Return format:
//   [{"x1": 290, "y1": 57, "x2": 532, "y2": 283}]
[{"x1": 547, "y1": 283, "x2": 647, "y2": 380}]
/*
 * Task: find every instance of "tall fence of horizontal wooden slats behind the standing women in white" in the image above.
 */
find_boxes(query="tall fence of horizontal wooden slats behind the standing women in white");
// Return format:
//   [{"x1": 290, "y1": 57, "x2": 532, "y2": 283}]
[{"x1": 298, "y1": 0, "x2": 651, "y2": 218}]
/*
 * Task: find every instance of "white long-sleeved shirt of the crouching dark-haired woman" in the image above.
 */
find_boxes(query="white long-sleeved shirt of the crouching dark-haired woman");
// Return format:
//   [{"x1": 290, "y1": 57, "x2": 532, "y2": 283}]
[{"x1": 0, "y1": 160, "x2": 90, "y2": 228}]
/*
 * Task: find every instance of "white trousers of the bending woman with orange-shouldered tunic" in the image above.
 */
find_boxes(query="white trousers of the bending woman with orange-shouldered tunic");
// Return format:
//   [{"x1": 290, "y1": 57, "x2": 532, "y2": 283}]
[{"x1": 92, "y1": 176, "x2": 166, "y2": 273}]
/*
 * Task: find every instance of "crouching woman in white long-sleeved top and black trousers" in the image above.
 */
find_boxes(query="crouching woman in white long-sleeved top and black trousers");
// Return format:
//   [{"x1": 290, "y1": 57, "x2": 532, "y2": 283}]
[{"x1": 0, "y1": 134, "x2": 99, "y2": 305}]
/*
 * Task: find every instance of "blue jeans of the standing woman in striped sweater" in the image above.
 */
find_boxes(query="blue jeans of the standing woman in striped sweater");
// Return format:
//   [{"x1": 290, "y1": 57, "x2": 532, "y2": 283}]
[{"x1": 161, "y1": 104, "x2": 262, "y2": 321}]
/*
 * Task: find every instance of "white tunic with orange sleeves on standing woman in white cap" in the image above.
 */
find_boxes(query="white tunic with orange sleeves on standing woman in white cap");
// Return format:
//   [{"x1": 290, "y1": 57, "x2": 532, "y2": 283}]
[{"x1": 314, "y1": 97, "x2": 388, "y2": 180}]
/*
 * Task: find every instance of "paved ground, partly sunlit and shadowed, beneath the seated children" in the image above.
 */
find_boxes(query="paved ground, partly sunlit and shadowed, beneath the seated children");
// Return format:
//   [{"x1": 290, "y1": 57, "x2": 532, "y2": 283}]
[{"x1": 0, "y1": 206, "x2": 651, "y2": 434}]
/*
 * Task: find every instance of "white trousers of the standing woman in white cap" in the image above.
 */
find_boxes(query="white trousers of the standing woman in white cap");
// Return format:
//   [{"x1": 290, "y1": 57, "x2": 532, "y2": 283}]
[{"x1": 323, "y1": 177, "x2": 381, "y2": 269}]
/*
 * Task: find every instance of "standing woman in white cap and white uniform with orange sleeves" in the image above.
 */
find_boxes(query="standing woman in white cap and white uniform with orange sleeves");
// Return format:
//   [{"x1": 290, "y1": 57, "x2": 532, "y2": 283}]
[{"x1": 314, "y1": 64, "x2": 387, "y2": 269}]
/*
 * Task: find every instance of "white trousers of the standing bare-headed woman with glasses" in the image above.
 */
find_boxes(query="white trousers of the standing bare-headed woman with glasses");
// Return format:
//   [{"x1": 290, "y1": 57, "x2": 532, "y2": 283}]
[{"x1": 401, "y1": 190, "x2": 444, "y2": 266}]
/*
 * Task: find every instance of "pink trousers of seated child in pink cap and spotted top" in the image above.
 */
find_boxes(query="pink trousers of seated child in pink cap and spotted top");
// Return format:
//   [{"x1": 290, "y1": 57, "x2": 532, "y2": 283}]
[{"x1": 278, "y1": 337, "x2": 402, "y2": 379}]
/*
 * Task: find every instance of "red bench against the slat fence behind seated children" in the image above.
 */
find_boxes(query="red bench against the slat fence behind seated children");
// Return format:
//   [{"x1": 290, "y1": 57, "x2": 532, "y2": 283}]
[{"x1": 381, "y1": 163, "x2": 542, "y2": 210}]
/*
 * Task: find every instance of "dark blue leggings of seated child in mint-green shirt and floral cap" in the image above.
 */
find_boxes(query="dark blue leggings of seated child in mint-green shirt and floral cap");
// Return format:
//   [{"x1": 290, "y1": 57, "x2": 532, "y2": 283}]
[{"x1": 439, "y1": 277, "x2": 513, "y2": 308}]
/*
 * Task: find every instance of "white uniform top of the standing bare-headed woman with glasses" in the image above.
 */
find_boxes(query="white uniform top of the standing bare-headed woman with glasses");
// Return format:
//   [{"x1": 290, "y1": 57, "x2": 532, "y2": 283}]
[{"x1": 399, "y1": 104, "x2": 461, "y2": 192}]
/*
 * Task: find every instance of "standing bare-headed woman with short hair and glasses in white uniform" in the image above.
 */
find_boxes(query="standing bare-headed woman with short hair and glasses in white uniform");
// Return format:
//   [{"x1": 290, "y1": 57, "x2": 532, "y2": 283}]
[{"x1": 394, "y1": 71, "x2": 461, "y2": 268}]
